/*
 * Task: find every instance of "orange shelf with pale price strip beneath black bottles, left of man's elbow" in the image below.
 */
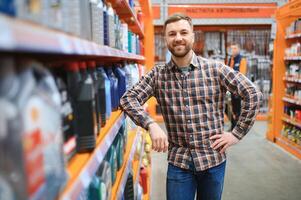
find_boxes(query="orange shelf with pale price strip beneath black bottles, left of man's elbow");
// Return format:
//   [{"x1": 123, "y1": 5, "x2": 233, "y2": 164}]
[{"x1": 59, "y1": 111, "x2": 125, "y2": 200}]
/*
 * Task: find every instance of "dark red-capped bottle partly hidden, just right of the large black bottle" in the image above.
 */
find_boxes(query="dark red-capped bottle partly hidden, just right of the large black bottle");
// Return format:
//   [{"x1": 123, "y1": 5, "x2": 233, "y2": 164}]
[{"x1": 87, "y1": 61, "x2": 103, "y2": 134}]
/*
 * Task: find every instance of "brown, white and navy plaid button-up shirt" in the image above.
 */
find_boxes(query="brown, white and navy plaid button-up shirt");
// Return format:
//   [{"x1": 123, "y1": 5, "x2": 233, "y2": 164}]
[{"x1": 120, "y1": 54, "x2": 262, "y2": 171}]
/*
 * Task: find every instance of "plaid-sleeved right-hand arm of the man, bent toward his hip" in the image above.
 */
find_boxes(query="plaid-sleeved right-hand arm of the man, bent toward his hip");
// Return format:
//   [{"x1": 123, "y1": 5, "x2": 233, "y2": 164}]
[{"x1": 218, "y1": 64, "x2": 262, "y2": 139}]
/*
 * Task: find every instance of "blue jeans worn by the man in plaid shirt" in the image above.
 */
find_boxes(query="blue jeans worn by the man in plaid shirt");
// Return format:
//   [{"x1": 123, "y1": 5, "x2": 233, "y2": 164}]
[{"x1": 166, "y1": 161, "x2": 226, "y2": 200}]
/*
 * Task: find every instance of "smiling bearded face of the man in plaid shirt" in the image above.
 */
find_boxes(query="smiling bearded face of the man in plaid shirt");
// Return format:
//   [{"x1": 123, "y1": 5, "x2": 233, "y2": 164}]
[{"x1": 165, "y1": 20, "x2": 194, "y2": 57}]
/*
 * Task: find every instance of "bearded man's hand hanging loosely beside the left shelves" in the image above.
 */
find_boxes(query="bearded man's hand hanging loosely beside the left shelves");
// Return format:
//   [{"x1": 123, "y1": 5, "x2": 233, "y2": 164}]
[{"x1": 149, "y1": 123, "x2": 168, "y2": 152}]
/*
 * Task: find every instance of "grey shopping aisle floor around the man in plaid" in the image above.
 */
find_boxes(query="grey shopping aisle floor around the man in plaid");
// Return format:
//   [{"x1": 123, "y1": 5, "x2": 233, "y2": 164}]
[{"x1": 151, "y1": 122, "x2": 301, "y2": 200}]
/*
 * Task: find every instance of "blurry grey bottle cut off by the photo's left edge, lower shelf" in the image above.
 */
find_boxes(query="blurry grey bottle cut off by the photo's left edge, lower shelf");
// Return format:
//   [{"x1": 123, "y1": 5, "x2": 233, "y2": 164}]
[{"x1": 0, "y1": 58, "x2": 25, "y2": 200}]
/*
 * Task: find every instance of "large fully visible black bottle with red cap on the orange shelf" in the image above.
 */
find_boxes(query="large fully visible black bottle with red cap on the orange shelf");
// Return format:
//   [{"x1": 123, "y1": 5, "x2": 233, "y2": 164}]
[{"x1": 76, "y1": 62, "x2": 97, "y2": 152}]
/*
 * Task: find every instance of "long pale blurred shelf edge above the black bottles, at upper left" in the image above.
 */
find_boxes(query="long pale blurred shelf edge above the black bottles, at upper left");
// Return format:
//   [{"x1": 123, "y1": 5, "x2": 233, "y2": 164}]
[{"x1": 0, "y1": 14, "x2": 144, "y2": 61}]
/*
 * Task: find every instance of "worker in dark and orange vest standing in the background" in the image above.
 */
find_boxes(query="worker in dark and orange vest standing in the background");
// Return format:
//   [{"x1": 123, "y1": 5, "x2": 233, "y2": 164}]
[{"x1": 228, "y1": 43, "x2": 247, "y2": 130}]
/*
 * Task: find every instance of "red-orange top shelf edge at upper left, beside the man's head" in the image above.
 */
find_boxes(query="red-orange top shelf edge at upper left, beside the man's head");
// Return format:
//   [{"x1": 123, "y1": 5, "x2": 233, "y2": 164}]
[{"x1": 107, "y1": 0, "x2": 144, "y2": 38}]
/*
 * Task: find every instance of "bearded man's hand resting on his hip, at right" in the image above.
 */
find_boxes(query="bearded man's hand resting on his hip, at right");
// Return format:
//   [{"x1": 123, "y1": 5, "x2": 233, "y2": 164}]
[{"x1": 210, "y1": 132, "x2": 239, "y2": 153}]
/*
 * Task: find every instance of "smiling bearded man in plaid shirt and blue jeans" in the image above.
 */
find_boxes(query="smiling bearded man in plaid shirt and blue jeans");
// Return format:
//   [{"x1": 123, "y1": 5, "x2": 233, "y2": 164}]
[{"x1": 120, "y1": 14, "x2": 262, "y2": 200}]
